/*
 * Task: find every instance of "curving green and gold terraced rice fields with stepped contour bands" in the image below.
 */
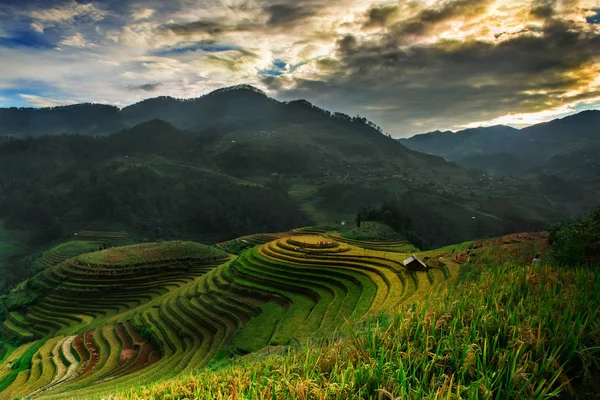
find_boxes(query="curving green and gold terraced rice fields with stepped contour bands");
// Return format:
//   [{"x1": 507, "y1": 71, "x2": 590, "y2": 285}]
[{"x1": 0, "y1": 230, "x2": 458, "y2": 399}]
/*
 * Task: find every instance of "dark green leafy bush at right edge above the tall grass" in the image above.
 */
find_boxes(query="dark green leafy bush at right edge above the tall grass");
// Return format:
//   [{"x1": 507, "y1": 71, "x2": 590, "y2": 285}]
[{"x1": 548, "y1": 208, "x2": 600, "y2": 265}]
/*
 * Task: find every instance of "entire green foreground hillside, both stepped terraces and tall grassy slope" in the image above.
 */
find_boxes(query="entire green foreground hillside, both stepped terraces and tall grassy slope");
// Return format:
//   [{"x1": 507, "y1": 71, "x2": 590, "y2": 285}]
[{"x1": 0, "y1": 229, "x2": 600, "y2": 399}]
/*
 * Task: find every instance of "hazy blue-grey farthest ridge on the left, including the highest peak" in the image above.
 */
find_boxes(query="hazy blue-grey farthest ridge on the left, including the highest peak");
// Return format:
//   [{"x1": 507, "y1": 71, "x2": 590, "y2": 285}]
[{"x1": 0, "y1": 85, "x2": 384, "y2": 137}]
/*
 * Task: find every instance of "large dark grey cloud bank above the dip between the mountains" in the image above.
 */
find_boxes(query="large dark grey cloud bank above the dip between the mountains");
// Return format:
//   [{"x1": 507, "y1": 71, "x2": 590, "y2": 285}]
[{"x1": 265, "y1": 16, "x2": 600, "y2": 136}]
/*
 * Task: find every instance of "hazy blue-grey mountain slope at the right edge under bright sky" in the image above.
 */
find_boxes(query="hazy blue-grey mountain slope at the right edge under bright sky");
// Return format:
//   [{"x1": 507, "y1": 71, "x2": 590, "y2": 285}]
[{"x1": 399, "y1": 111, "x2": 600, "y2": 212}]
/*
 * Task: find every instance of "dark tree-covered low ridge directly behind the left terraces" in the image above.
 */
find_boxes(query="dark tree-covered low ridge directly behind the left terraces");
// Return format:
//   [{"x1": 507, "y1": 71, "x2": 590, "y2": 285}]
[{"x1": 0, "y1": 166, "x2": 308, "y2": 241}]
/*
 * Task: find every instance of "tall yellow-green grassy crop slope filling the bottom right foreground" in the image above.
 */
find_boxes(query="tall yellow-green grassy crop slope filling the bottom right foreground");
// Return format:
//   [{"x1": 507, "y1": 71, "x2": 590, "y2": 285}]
[{"x1": 111, "y1": 265, "x2": 600, "y2": 399}]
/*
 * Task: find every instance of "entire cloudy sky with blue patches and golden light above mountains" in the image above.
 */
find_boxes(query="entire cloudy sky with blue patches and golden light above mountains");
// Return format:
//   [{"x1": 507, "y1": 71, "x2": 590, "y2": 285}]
[{"x1": 0, "y1": 0, "x2": 600, "y2": 137}]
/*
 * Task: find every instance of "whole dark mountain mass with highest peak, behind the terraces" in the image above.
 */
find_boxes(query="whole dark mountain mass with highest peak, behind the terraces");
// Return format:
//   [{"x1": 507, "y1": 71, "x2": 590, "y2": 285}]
[{"x1": 0, "y1": 86, "x2": 595, "y2": 246}]
